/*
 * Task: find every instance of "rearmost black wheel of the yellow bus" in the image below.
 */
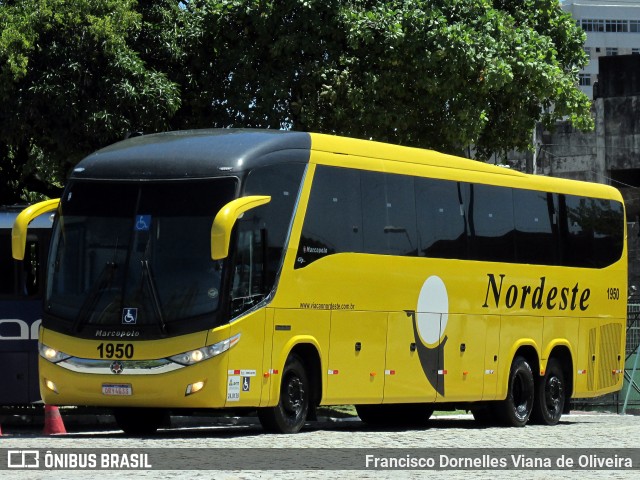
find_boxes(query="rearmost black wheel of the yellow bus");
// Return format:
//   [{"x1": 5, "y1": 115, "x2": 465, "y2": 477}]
[{"x1": 531, "y1": 358, "x2": 567, "y2": 425}]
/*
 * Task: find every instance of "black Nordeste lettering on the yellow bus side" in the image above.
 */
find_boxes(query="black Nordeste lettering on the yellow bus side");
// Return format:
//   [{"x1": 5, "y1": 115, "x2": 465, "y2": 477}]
[{"x1": 482, "y1": 273, "x2": 591, "y2": 312}]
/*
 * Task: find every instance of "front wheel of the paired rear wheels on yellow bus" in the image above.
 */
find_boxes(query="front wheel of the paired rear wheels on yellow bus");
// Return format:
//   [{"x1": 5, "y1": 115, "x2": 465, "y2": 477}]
[{"x1": 495, "y1": 357, "x2": 535, "y2": 427}]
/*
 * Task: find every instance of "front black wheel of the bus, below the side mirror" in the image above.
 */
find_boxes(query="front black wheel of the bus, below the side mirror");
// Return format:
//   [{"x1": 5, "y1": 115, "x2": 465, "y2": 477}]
[{"x1": 258, "y1": 354, "x2": 311, "y2": 433}]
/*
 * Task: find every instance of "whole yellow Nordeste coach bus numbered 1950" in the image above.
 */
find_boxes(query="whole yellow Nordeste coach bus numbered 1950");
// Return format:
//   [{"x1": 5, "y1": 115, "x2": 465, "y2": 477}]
[{"x1": 13, "y1": 129, "x2": 627, "y2": 433}]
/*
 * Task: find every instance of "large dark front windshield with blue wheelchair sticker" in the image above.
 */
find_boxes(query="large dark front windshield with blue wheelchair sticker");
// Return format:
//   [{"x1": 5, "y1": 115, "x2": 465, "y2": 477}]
[{"x1": 45, "y1": 178, "x2": 237, "y2": 333}]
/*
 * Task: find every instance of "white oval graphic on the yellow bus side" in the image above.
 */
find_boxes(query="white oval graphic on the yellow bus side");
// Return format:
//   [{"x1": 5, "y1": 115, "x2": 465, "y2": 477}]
[{"x1": 416, "y1": 275, "x2": 449, "y2": 345}]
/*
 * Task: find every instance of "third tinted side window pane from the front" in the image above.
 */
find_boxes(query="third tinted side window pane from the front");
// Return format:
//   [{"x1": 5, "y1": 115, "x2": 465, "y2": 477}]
[{"x1": 415, "y1": 178, "x2": 467, "y2": 259}]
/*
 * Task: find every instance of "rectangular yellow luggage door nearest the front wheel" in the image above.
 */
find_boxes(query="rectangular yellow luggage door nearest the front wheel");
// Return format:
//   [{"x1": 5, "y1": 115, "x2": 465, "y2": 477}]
[{"x1": 327, "y1": 310, "x2": 387, "y2": 404}]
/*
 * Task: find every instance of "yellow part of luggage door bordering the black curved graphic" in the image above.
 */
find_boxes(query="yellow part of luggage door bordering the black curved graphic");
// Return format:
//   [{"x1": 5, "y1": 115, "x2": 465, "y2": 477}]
[{"x1": 384, "y1": 312, "x2": 437, "y2": 403}]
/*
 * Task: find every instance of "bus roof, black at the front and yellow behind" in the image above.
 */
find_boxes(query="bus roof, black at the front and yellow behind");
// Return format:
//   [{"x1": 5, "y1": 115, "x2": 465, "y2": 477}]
[{"x1": 71, "y1": 129, "x2": 621, "y2": 200}]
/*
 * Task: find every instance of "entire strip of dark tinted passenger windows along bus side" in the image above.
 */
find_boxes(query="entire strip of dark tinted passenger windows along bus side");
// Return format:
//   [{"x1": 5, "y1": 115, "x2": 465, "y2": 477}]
[{"x1": 296, "y1": 166, "x2": 624, "y2": 268}]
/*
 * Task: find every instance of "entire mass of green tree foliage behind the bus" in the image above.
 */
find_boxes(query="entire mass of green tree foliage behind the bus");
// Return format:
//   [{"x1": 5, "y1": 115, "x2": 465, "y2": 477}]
[{"x1": 0, "y1": 0, "x2": 592, "y2": 201}]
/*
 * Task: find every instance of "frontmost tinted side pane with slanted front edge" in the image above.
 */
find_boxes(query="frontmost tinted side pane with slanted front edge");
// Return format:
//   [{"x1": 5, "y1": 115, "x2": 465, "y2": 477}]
[{"x1": 295, "y1": 165, "x2": 362, "y2": 268}]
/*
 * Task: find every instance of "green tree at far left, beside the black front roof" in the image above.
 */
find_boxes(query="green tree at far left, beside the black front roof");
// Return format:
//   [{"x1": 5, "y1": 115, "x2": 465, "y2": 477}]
[{"x1": 0, "y1": 0, "x2": 180, "y2": 203}]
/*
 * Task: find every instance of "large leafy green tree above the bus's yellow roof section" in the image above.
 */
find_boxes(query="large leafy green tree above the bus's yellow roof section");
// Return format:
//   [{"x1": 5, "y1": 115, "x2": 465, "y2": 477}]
[{"x1": 164, "y1": 0, "x2": 592, "y2": 159}]
